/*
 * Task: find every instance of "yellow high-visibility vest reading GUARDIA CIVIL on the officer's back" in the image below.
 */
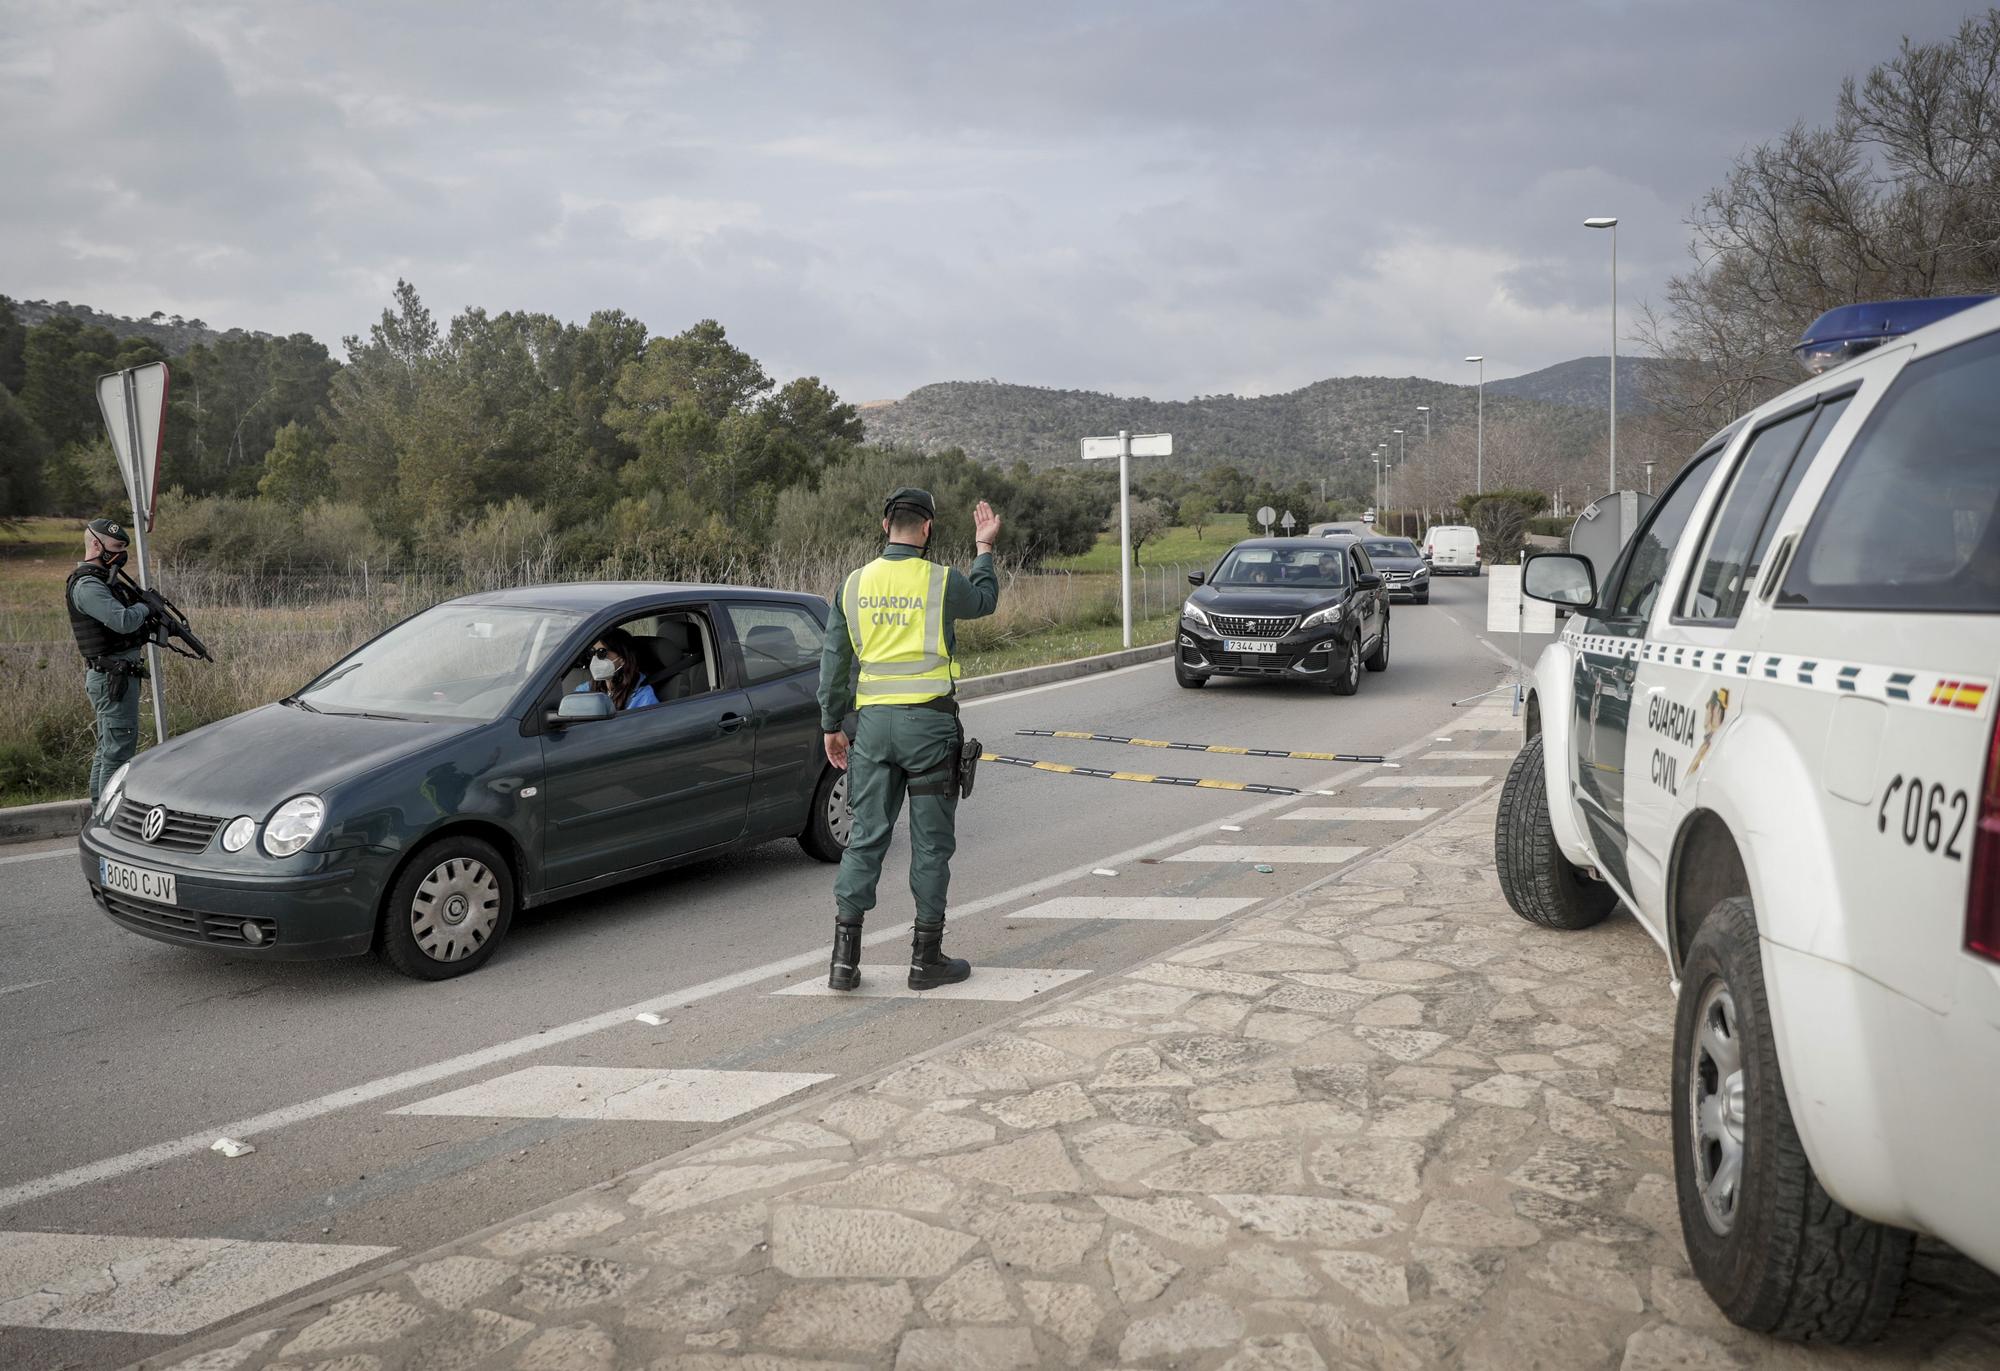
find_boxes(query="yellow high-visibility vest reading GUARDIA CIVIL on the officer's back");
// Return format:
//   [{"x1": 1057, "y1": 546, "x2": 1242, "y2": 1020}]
[{"x1": 840, "y1": 558, "x2": 958, "y2": 705}]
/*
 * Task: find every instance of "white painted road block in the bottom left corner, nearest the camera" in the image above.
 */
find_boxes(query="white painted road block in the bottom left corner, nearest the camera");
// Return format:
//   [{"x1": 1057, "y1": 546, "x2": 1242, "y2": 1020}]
[{"x1": 0, "y1": 1233, "x2": 396, "y2": 1333}]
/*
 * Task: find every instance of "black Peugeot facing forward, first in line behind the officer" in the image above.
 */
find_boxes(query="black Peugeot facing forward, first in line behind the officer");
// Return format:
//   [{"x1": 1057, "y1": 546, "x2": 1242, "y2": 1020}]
[{"x1": 1174, "y1": 538, "x2": 1388, "y2": 695}]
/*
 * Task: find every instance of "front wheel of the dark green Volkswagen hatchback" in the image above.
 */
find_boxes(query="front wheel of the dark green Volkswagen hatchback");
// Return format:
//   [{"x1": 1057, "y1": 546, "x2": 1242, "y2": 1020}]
[{"x1": 380, "y1": 835, "x2": 514, "y2": 981}]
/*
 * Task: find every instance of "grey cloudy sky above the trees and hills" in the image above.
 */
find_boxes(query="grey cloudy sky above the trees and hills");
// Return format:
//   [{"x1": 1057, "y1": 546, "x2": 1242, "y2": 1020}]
[{"x1": 0, "y1": 0, "x2": 1972, "y2": 400}]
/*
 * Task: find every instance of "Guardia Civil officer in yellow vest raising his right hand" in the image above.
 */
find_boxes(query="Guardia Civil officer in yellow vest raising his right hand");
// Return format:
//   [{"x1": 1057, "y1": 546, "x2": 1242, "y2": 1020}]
[{"x1": 820, "y1": 486, "x2": 1000, "y2": 989}]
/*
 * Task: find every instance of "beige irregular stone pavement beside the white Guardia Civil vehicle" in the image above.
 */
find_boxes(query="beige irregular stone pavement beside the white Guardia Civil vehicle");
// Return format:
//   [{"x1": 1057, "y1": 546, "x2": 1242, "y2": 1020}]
[{"x1": 146, "y1": 797, "x2": 2000, "y2": 1371}]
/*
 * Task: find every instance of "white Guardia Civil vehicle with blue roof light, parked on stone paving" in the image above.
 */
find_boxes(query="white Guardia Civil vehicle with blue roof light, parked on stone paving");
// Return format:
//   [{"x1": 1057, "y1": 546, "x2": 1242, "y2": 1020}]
[{"x1": 1494, "y1": 300, "x2": 2000, "y2": 1341}]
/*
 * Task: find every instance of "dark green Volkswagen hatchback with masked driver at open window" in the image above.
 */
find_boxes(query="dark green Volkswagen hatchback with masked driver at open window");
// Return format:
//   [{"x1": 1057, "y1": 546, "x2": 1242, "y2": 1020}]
[{"x1": 78, "y1": 582, "x2": 850, "y2": 979}]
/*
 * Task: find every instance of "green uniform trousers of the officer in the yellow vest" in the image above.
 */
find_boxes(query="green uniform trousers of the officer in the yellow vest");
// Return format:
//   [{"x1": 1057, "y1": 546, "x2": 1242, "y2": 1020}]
[{"x1": 834, "y1": 705, "x2": 958, "y2": 927}]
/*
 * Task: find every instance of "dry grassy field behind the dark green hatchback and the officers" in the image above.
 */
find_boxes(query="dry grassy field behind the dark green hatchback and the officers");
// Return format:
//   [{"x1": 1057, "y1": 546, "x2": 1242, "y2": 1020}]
[{"x1": 0, "y1": 520, "x2": 1186, "y2": 805}]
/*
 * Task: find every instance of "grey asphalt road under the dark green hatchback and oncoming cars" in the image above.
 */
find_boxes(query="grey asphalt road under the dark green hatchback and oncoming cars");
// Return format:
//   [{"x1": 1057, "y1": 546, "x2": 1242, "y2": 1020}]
[{"x1": 0, "y1": 582, "x2": 1540, "y2": 1367}]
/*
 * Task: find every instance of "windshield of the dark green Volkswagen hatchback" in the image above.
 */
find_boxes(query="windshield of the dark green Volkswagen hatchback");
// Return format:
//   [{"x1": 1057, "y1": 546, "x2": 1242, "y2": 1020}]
[{"x1": 292, "y1": 604, "x2": 582, "y2": 721}]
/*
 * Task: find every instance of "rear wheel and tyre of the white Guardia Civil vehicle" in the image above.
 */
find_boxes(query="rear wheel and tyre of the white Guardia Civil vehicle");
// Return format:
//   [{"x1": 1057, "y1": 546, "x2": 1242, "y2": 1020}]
[{"x1": 1672, "y1": 895, "x2": 1916, "y2": 1343}]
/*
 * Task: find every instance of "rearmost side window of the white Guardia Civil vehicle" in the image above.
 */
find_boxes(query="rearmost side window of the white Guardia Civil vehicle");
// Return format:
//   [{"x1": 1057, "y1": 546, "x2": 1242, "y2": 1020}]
[{"x1": 1778, "y1": 334, "x2": 2000, "y2": 614}]
